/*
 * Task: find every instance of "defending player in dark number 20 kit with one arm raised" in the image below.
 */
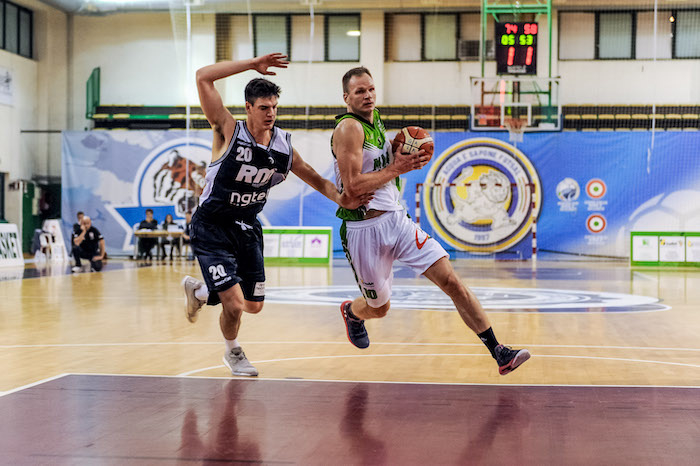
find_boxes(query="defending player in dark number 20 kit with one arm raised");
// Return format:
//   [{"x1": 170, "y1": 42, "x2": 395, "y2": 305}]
[{"x1": 182, "y1": 53, "x2": 372, "y2": 376}]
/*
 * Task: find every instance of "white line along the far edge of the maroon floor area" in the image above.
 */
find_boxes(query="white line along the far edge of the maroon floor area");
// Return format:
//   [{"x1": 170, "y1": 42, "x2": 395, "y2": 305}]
[{"x1": 42, "y1": 372, "x2": 700, "y2": 389}]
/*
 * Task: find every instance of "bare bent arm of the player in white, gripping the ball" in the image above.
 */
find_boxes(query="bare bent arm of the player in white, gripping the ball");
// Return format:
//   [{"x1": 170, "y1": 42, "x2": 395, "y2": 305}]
[{"x1": 333, "y1": 118, "x2": 423, "y2": 197}]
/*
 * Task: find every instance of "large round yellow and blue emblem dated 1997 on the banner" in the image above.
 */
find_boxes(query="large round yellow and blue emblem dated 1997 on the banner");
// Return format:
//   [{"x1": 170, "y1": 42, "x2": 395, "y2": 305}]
[{"x1": 423, "y1": 138, "x2": 541, "y2": 253}]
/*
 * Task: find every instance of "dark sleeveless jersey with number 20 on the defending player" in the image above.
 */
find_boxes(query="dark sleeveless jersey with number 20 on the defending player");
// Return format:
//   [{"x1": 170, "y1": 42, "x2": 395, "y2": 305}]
[{"x1": 197, "y1": 121, "x2": 293, "y2": 223}]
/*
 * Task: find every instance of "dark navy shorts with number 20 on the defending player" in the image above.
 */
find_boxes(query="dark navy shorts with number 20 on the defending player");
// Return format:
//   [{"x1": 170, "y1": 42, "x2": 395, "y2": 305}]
[{"x1": 190, "y1": 213, "x2": 265, "y2": 305}]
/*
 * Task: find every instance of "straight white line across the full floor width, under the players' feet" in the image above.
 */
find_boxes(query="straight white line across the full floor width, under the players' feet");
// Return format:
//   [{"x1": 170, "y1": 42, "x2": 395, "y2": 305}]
[{"x1": 0, "y1": 340, "x2": 700, "y2": 351}]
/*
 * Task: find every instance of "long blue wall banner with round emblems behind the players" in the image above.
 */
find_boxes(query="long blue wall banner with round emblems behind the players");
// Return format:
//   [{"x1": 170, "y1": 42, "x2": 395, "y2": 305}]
[{"x1": 62, "y1": 131, "x2": 700, "y2": 258}]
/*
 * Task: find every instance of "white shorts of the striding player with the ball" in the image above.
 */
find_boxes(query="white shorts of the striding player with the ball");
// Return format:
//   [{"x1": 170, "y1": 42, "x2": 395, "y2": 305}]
[{"x1": 341, "y1": 210, "x2": 448, "y2": 308}]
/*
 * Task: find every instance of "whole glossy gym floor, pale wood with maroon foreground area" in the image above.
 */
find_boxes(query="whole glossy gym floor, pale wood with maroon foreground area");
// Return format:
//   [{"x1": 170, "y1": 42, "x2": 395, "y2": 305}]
[{"x1": 0, "y1": 260, "x2": 700, "y2": 464}]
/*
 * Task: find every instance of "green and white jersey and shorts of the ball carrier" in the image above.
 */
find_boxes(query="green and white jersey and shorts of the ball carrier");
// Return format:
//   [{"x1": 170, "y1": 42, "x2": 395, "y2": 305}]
[{"x1": 331, "y1": 109, "x2": 448, "y2": 308}]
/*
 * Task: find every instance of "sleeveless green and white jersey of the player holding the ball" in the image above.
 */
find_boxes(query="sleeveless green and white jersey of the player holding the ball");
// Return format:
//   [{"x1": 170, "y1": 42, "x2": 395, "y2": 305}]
[{"x1": 331, "y1": 109, "x2": 403, "y2": 220}]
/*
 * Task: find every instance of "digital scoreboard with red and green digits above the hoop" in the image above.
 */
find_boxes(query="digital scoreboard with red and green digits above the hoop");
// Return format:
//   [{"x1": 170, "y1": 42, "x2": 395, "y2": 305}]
[{"x1": 496, "y1": 22, "x2": 538, "y2": 74}]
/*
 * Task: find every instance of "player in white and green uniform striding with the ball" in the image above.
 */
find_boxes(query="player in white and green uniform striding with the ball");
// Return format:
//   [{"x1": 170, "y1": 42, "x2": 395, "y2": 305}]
[{"x1": 331, "y1": 67, "x2": 530, "y2": 375}]
